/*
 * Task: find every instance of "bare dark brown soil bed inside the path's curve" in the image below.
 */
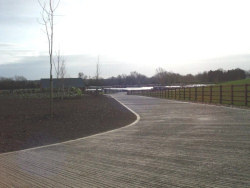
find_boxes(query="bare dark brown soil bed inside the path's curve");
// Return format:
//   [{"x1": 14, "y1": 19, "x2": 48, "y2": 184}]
[{"x1": 0, "y1": 95, "x2": 136, "y2": 153}]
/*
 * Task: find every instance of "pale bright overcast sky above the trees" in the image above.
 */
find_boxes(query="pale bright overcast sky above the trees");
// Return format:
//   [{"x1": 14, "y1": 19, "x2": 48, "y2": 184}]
[{"x1": 0, "y1": 0, "x2": 250, "y2": 80}]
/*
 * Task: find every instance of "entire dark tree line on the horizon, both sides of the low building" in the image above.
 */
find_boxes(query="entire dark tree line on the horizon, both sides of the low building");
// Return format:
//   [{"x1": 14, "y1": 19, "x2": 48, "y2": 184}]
[{"x1": 0, "y1": 68, "x2": 250, "y2": 90}]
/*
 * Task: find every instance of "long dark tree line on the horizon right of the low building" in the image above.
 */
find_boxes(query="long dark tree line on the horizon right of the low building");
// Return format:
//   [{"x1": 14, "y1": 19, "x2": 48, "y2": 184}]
[{"x1": 79, "y1": 68, "x2": 250, "y2": 86}]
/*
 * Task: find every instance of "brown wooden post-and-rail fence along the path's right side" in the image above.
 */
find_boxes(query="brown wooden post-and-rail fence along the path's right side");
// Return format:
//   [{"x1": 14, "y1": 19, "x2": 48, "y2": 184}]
[{"x1": 128, "y1": 84, "x2": 250, "y2": 107}]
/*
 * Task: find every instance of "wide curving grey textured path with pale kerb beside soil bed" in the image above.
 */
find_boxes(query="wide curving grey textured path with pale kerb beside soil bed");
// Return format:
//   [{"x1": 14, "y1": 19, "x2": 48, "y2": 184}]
[{"x1": 0, "y1": 94, "x2": 250, "y2": 188}]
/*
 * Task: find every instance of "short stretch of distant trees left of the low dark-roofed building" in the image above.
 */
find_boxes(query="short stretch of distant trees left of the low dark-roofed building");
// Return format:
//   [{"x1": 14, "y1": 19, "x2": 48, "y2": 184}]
[{"x1": 0, "y1": 76, "x2": 40, "y2": 90}]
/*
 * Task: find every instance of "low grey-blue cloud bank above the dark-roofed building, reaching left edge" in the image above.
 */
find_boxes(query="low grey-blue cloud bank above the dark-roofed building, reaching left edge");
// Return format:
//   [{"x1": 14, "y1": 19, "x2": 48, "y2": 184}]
[{"x1": 0, "y1": 55, "x2": 155, "y2": 80}]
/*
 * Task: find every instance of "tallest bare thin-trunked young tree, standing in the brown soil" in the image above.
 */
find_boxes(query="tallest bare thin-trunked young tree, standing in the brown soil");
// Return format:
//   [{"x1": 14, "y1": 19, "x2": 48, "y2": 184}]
[{"x1": 38, "y1": 0, "x2": 60, "y2": 118}]
